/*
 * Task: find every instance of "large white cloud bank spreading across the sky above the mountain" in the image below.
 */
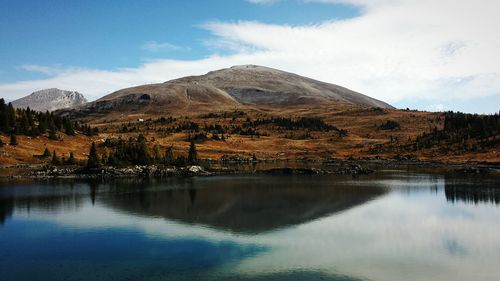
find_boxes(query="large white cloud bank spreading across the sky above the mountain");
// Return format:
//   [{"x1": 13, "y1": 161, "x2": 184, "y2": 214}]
[{"x1": 0, "y1": 0, "x2": 500, "y2": 112}]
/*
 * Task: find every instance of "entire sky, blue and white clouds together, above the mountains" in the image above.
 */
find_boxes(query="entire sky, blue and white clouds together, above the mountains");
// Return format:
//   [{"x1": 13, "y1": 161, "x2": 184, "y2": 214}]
[{"x1": 0, "y1": 0, "x2": 500, "y2": 113}]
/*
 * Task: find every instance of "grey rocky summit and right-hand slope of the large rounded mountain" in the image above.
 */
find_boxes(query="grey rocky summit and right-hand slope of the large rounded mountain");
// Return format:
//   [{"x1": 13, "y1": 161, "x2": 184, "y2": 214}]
[{"x1": 191, "y1": 65, "x2": 392, "y2": 108}]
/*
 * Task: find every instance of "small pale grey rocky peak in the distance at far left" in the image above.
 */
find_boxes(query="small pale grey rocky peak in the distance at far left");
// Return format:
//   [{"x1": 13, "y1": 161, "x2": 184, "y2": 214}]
[{"x1": 12, "y1": 88, "x2": 87, "y2": 111}]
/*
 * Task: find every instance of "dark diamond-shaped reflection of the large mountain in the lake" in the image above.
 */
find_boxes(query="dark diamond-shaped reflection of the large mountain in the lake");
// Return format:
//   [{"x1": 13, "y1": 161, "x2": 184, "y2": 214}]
[{"x1": 103, "y1": 176, "x2": 385, "y2": 233}]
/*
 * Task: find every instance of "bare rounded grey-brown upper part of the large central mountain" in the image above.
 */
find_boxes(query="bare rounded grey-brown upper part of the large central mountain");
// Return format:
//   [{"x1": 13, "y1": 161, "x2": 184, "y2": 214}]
[{"x1": 61, "y1": 65, "x2": 393, "y2": 116}]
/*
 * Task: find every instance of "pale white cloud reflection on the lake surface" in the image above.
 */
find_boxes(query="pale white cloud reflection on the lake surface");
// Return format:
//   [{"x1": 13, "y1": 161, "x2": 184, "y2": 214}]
[{"x1": 23, "y1": 180, "x2": 500, "y2": 281}]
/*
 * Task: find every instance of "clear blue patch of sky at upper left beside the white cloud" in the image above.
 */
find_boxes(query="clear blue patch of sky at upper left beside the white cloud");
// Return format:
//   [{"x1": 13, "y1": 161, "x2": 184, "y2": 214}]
[{"x1": 0, "y1": 0, "x2": 359, "y2": 82}]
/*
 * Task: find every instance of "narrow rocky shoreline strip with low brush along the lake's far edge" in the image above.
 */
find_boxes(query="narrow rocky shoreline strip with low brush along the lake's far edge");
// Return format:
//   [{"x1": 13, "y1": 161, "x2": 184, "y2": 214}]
[{"x1": 0, "y1": 159, "x2": 500, "y2": 179}]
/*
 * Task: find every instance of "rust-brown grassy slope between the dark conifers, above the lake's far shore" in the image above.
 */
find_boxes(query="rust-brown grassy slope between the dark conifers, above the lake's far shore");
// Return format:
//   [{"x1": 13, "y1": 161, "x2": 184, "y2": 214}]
[{"x1": 0, "y1": 105, "x2": 500, "y2": 165}]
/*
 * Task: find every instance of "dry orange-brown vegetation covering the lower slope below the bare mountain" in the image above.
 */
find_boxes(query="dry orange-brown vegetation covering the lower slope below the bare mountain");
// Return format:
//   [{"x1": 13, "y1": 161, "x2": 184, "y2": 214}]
[{"x1": 0, "y1": 104, "x2": 500, "y2": 165}]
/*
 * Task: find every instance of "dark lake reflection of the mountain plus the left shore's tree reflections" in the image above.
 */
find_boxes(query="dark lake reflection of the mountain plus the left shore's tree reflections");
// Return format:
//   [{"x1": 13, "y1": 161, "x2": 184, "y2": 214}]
[{"x1": 0, "y1": 176, "x2": 386, "y2": 233}]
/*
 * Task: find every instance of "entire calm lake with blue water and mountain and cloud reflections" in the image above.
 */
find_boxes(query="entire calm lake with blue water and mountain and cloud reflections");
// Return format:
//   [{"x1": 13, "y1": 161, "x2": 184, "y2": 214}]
[{"x1": 0, "y1": 170, "x2": 500, "y2": 281}]
